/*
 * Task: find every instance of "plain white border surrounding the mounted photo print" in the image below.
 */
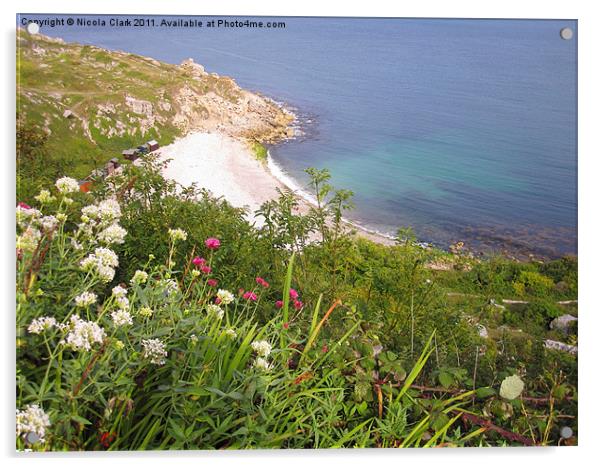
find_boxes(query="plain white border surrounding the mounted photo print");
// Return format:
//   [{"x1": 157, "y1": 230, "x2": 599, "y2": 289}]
[{"x1": 0, "y1": 0, "x2": 602, "y2": 466}]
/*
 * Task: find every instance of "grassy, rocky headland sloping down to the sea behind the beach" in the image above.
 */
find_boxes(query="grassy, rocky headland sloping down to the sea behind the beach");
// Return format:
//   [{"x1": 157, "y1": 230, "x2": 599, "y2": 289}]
[{"x1": 17, "y1": 30, "x2": 292, "y2": 183}]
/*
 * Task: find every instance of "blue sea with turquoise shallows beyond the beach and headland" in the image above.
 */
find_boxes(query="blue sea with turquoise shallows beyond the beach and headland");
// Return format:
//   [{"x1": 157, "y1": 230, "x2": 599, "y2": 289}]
[{"x1": 21, "y1": 16, "x2": 577, "y2": 256}]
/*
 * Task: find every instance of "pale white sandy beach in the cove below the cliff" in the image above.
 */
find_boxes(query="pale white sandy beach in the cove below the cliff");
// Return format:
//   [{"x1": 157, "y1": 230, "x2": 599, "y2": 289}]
[{"x1": 159, "y1": 131, "x2": 394, "y2": 245}]
